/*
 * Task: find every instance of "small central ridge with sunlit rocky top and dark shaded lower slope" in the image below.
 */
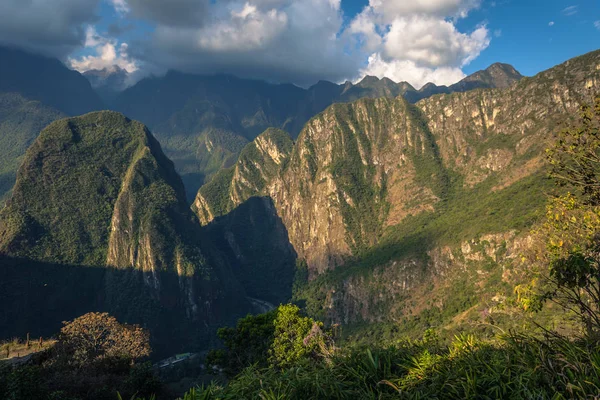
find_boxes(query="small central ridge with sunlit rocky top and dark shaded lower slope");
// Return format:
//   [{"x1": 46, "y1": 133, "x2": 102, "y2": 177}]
[{"x1": 192, "y1": 128, "x2": 297, "y2": 304}]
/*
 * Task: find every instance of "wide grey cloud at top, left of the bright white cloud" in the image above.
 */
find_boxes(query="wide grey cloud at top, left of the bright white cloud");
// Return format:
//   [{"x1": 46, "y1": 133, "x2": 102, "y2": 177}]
[{"x1": 128, "y1": 0, "x2": 361, "y2": 85}]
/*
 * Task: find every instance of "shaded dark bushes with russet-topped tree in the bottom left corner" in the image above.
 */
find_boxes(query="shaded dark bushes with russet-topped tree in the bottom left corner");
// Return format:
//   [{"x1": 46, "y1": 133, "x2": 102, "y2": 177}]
[{"x1": 0, "y1": 313, "x2": 161, "y2": 400}]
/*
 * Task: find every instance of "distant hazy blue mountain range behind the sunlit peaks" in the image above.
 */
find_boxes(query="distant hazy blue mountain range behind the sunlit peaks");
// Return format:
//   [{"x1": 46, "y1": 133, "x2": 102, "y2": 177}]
[{"x1": 0, "y1": 47, "x2": 520, "y2": 205}]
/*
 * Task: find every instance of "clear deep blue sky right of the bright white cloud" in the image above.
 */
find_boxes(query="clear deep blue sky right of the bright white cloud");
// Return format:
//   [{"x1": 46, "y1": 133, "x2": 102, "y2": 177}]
[{"x1": 342, "y1": 0, "x2": 600, "y2": 75}]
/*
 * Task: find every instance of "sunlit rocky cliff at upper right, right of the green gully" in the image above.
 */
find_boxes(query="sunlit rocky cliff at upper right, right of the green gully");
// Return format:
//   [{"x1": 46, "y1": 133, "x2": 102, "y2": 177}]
[{"x1": 417, "y1": 52, "x2": 600, "y2": 187}]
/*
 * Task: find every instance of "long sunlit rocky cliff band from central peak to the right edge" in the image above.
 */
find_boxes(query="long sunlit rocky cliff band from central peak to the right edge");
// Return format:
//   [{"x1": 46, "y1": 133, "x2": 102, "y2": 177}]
[{"x1": 196, "y1": 52, "x2": 600, "y2": 274}]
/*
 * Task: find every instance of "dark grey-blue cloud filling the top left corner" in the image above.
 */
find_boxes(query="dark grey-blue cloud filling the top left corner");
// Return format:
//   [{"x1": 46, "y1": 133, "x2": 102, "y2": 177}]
[{"x1": 0, "y1": 0, "x2": 99, "y2": 58}]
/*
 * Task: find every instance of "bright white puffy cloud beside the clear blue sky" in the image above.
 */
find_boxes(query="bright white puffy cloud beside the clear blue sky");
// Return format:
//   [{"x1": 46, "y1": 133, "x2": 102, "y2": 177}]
[{"x1": 348, "y1": 0, "x2": 490, "y2": 87}]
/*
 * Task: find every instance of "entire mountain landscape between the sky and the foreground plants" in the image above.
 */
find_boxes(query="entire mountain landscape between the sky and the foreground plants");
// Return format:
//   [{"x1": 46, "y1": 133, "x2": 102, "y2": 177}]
[{"x1": 0, "y1": 43, "x2": 600, "y2": 353}]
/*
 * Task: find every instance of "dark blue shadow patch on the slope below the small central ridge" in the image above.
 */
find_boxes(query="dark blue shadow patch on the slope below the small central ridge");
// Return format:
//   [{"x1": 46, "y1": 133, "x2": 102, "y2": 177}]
[{"x1": 204, "y1": 197, "x2": 297, "y2": 305}]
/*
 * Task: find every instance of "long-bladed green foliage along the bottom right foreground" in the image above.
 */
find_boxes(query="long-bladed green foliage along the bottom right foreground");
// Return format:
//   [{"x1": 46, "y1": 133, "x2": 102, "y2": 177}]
[{"x1": 184, "y1": 334, "x2": 600, "y2": 399}]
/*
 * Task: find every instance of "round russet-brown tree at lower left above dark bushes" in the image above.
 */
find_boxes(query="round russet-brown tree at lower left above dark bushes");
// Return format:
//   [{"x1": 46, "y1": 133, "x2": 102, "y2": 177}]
[{"x1": 56, "y1": 313, "x2": 151, "y2": 366}]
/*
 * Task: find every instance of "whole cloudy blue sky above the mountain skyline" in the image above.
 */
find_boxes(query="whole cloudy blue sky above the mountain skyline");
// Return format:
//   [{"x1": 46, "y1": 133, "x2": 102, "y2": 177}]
[{"x1": 0, "y1": 0, "x2": 600, "y2": 88}]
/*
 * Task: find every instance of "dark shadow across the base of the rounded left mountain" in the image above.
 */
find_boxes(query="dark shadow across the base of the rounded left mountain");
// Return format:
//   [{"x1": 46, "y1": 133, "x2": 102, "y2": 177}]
[{"x1": 0, "y1": 255, "x2": 248, "y2": 358}]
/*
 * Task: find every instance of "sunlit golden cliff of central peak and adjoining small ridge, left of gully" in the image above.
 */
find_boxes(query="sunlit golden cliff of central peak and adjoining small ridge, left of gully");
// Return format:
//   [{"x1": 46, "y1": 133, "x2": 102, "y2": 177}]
[{"x1": 194, "y1": 98, "x2": 446, "y2": 273}]
